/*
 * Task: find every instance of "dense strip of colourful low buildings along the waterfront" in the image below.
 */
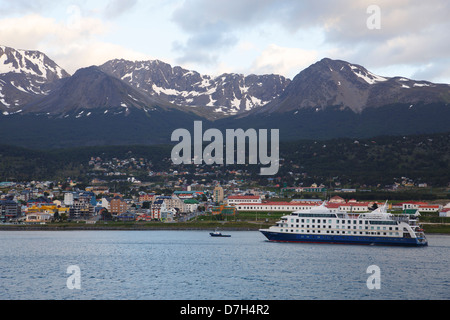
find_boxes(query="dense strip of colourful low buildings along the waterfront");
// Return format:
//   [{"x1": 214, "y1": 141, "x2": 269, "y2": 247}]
[{"x1": 0, "y1": 175, "x2": 450, "y2": 230}]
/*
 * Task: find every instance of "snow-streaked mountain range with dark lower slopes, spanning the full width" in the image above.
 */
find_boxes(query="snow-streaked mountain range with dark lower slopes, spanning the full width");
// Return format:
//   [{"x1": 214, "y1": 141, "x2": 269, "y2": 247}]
[{"x1": 0, "y1": 46, "x2": 450, "y2": 147}]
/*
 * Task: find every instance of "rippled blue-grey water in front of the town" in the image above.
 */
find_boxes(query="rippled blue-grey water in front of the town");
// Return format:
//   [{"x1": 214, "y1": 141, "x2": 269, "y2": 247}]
[{"x1": 0, "y1": 231, "x2": 450, "y2": 300}]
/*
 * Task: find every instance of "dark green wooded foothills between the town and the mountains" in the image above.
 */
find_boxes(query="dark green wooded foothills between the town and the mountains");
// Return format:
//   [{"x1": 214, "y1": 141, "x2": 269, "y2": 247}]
[{"x1": 0, "y1": 133, "x2": 450, "y2": 187}]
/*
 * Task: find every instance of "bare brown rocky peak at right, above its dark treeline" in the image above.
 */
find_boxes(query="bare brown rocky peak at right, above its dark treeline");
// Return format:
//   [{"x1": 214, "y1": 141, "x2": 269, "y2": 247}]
[{"x1": 250, "y1": 58, "x2": 450, "y2": 113}]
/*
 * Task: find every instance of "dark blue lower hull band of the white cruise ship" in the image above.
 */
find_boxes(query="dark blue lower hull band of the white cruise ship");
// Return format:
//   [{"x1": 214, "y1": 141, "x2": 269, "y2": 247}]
[{"x1": 261, "y1": 231, "x2": 427, "y2": 246}]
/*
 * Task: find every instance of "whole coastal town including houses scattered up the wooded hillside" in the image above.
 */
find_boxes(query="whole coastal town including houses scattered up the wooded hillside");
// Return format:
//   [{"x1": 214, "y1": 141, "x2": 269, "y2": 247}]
[{"x1": 0, "y1": 139, "x2": 450, "y2": 232}]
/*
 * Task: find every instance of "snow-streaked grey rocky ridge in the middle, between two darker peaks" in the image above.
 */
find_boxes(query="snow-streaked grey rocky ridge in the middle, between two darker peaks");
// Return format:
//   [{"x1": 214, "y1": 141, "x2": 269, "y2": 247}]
[{"x1": 100, "y1": 60, "x2": 290, "y2": 116}]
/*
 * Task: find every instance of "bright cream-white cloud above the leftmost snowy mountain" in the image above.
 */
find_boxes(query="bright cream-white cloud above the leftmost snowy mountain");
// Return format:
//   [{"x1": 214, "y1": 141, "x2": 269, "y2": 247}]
[{"x1": 0, "y1": 13, "x2": 150, "y2": 74}]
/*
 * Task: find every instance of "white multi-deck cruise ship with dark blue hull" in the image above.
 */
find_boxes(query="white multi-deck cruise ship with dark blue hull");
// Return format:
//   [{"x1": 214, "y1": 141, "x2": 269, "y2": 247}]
[{"x1": 260, "y1": 201, "x2": 428, "y2": 246}]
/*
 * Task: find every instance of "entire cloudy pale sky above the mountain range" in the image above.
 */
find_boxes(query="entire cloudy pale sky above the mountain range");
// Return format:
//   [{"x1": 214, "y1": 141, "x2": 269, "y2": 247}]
[{"x1": 0, "y1": 0, "x2": 450, "y2": 83}]
